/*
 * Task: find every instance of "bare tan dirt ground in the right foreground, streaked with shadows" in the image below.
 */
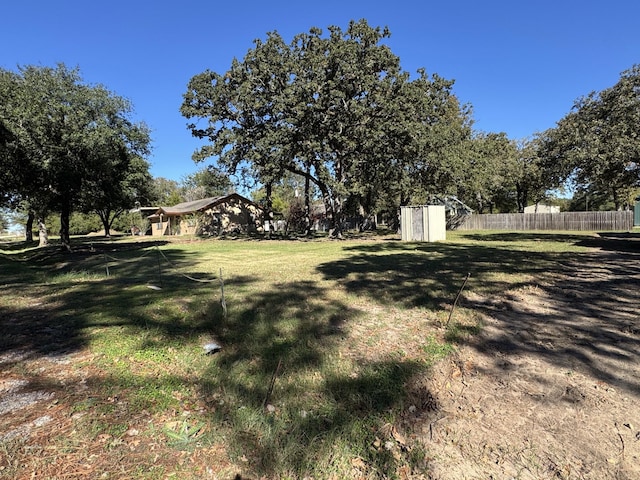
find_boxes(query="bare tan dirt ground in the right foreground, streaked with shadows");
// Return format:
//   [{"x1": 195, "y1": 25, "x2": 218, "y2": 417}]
[{"x1": 406, "y1": 238, "x2": 640, "y2": 480}]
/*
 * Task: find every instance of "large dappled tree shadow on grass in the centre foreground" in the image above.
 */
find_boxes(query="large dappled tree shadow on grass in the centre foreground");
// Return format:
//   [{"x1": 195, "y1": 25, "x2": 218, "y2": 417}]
[{"x1": 201, "y1": 282, "x2": 425, "y2": 478}]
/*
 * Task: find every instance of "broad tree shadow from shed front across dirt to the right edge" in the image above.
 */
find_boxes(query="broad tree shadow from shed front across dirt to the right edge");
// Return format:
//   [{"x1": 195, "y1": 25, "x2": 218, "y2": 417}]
[{"x1": 319, "y1": 233, "x2": 640, "y2": 395}]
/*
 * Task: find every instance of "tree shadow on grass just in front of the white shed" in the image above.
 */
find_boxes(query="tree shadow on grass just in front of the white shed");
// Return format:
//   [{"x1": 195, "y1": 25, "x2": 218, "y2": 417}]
[{"x1": 318, "y1": 242, "x2": 562, "y2": 309}]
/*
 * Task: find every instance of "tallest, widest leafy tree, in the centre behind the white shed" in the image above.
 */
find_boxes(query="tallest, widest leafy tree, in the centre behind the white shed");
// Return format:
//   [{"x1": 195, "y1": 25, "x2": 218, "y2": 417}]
[{"x1": 181, "y1": 20, "x2": 470, "y2": 235}]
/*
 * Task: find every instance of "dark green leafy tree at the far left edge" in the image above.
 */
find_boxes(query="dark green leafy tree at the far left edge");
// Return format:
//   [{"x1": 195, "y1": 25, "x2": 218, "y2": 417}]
[{"x1": 0, "y1": 64, "x2": 150, "y2": 248}]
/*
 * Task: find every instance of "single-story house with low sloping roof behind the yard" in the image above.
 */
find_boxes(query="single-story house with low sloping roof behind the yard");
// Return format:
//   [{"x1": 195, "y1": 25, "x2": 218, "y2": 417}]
[{"x1": 148, "y1": 193, "x2": 263, "y2": 236}]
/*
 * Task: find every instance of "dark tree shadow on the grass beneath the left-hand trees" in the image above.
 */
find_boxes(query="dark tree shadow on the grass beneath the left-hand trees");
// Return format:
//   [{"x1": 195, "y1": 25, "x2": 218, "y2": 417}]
[{"x1": 0, "y1": 236, "x2": 225, "y2": 367}]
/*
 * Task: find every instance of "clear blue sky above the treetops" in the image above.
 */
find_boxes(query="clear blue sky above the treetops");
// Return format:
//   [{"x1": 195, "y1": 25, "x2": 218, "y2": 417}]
[{"x1": 0, "y1": 0, "x2": 640, "y2": 180}]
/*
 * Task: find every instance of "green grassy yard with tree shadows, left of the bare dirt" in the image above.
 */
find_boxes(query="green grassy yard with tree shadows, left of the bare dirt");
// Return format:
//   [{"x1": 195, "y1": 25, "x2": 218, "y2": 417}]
[{"x1": 0, "y1": 232, "x2": 593, "y2": 479}]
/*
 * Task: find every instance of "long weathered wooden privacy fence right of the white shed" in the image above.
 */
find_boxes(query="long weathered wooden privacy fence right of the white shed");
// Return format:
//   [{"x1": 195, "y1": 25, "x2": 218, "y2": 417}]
[{"x1": 458, "y1": 211, "x2": 633, "y2": 231}]
